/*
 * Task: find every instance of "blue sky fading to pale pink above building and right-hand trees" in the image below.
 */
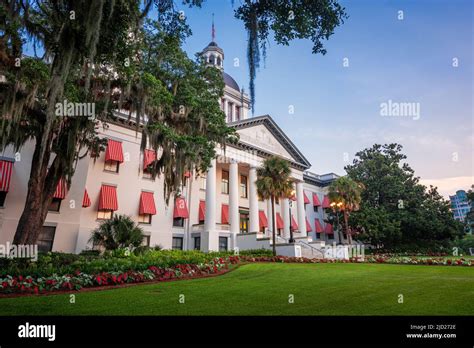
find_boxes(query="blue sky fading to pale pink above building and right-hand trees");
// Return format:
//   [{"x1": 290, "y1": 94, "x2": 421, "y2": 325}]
[{"x1": 179, "y1": 0, "x2": 474, "y2": 195}]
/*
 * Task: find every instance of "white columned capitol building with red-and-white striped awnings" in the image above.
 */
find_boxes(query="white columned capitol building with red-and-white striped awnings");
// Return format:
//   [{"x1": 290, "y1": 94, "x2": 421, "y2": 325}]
[{"x1": 0, "y1": 41, "x2": 345, "y2": 253}]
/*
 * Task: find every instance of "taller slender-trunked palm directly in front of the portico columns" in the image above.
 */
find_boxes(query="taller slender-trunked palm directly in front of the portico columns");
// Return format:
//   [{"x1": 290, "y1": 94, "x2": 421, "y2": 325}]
[{"x1": 256, "y1": 156, "x2": 293, "y2": 256}]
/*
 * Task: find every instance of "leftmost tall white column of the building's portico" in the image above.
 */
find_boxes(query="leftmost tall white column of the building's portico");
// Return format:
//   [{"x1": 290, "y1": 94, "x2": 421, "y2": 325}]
[{"x1": 201, "y1": 159, "x2": 219, "y2": 251}]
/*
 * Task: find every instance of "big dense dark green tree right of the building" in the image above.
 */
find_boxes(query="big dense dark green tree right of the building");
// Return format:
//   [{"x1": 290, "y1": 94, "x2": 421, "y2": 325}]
[{"x1": 345, "y1": 144, "x2": 462, "y2": 248}]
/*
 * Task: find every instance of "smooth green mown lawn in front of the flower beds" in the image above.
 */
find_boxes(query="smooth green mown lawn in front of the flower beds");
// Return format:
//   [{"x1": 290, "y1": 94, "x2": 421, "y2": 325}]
[{"x1": 0, "y1": 263, "x2": 474, "y2": 315}]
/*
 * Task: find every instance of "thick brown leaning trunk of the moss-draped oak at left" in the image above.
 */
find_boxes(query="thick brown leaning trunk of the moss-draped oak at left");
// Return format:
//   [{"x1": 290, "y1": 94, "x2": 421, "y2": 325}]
[{"x1": 13, "y1": 138, "x2": 62, "y2": 245}]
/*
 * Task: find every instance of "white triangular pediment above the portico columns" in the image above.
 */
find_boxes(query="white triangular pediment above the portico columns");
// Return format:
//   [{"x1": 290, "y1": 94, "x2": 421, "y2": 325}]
[{"x1": 229, "y1": 115, "x2": 311, "y2": 169}]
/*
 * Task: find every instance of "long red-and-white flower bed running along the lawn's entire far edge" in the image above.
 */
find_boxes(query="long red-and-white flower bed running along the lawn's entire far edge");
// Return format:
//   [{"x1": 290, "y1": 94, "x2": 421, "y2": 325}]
[{"x1": 0, "y1": 253, "x2": 474, "y2": 294}]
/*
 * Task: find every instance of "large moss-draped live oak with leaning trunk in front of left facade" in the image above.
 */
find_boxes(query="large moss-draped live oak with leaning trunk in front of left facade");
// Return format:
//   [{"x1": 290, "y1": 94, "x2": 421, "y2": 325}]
[{"x1": 0, "y1": 0, "x2": 232, "y2": 244}]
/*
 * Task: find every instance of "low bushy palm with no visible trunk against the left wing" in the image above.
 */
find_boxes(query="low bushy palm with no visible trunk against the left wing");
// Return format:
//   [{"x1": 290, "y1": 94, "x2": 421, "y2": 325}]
[{"x1": 89, "y1": 215, "x2": 144, "y2": 250}]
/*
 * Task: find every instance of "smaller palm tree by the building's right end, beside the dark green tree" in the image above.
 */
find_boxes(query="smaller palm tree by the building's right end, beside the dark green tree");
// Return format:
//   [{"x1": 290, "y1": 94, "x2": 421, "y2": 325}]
[{"x1": 328, "y1": 176, "x2": 364, "y2": 244}]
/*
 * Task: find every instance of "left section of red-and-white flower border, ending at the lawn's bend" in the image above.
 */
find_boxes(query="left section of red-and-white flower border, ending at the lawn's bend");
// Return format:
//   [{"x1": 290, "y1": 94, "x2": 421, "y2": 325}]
[{"x1": 0, "y1": 256, "x2": 243, "y2": 294}]
